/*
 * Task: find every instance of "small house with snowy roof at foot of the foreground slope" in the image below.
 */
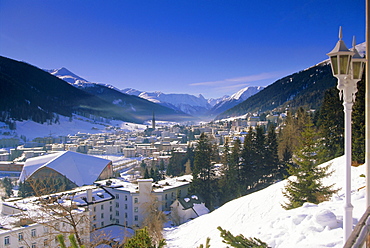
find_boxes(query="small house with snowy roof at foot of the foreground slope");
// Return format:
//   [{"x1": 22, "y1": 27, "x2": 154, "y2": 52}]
[{"x1": 170, "y1": 195, "x2": 209, "y2": 225}]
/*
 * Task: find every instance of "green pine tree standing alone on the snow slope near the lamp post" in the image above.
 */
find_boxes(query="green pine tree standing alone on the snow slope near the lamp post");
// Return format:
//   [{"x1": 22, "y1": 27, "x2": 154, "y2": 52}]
[{"x1": 282, "y1": 119, "x2": 337, "y2": 209}]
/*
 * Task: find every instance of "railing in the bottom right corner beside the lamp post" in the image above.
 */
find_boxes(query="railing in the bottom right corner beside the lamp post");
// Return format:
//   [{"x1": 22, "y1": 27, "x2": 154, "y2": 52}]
[{"x1": 343, "y1": 206, "x2": 370, "y2": 248}]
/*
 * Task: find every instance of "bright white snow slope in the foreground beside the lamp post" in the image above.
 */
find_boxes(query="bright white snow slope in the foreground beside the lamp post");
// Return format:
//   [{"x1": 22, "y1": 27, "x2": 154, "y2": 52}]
[{"x1": 165, "y1": 157, "x2": 365, "y2": 248}]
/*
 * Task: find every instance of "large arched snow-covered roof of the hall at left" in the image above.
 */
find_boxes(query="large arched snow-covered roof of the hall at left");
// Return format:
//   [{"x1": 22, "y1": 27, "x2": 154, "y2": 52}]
[{"x1": 19, "y1": 151, "x2": 111, "y2": 186}]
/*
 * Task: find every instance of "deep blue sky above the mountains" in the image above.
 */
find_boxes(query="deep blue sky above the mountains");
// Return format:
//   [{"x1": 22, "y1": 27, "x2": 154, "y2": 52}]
[{"x1": 0, "y1": 0, "x2": 365, "y2": 98}]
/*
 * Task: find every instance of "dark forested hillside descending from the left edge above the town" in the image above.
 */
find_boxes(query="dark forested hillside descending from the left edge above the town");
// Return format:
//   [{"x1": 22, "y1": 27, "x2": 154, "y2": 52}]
[{"x1": 0, "y1": 56, "x2": 191, "y2": 123}]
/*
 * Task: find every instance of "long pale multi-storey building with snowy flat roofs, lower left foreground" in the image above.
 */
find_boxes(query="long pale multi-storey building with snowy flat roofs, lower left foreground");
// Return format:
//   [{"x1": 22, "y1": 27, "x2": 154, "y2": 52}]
[{"x1": 0, "y1": 176, "x2": 191, "y2": 248}]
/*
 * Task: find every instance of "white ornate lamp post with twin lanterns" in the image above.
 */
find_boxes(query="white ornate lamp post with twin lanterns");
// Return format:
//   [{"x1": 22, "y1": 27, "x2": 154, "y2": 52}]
[{"x1": 328, "y1": 28, "x2": 365, "y2": 243}]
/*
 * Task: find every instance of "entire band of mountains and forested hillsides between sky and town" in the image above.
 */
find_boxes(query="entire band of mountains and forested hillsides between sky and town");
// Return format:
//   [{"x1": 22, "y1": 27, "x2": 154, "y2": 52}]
[{"x1": 0, "y1": 44, "x2": 364, "y2": 138}]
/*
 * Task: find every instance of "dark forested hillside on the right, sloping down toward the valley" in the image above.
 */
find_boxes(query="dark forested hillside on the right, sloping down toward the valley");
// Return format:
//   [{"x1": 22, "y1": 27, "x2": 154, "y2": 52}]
[{"x1": 216, "y1": 63, "x2": 336, "y2": 119}]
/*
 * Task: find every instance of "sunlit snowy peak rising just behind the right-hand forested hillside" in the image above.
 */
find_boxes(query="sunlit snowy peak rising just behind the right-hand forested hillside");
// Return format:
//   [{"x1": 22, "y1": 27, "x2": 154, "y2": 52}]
[{"x1": 210, "y1": 86, "x2": 264, "y2": 115}]
